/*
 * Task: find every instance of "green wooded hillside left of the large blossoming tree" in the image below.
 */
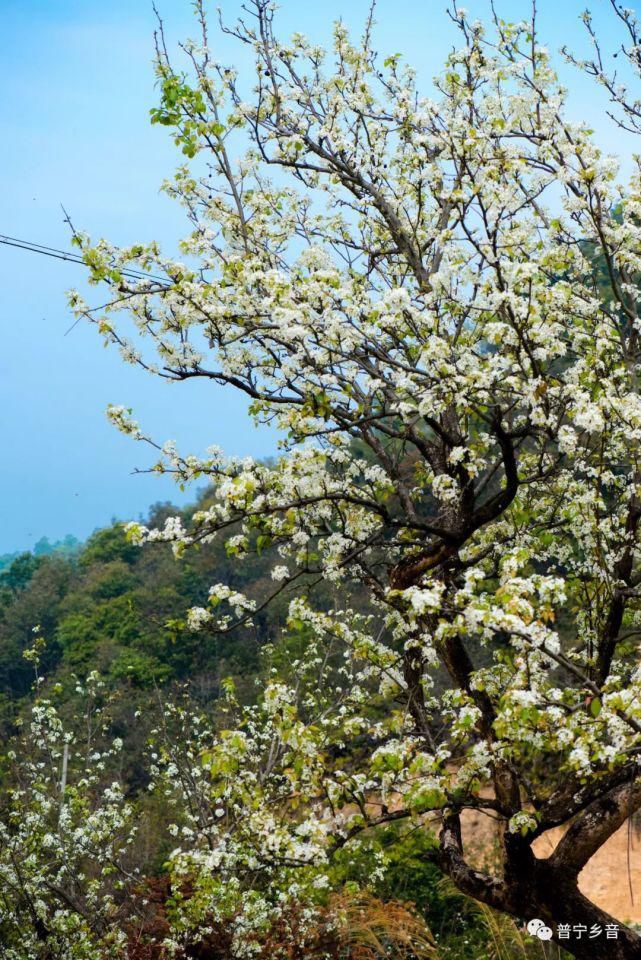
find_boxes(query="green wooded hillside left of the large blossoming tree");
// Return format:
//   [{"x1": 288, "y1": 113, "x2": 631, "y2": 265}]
[{"x1": 0, "y1": 491, "x2": 338, "y2": 787}]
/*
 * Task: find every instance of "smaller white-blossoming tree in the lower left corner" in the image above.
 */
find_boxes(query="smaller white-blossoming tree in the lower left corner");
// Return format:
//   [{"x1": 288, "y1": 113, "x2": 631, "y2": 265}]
[{"x1": 0, "y1": 668, "x2": 141, "y2": 960}]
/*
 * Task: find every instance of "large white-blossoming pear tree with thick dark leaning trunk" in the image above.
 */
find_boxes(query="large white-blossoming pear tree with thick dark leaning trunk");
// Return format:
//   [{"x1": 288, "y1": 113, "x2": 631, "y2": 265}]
[{"x1": 73, "y1": 0, "x2": 641, "y2": 960}]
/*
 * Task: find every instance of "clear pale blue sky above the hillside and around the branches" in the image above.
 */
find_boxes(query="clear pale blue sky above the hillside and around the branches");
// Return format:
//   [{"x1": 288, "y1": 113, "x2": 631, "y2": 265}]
[{"x1": 0, "y1": 0, "x2": 625, "y2": 553}]
